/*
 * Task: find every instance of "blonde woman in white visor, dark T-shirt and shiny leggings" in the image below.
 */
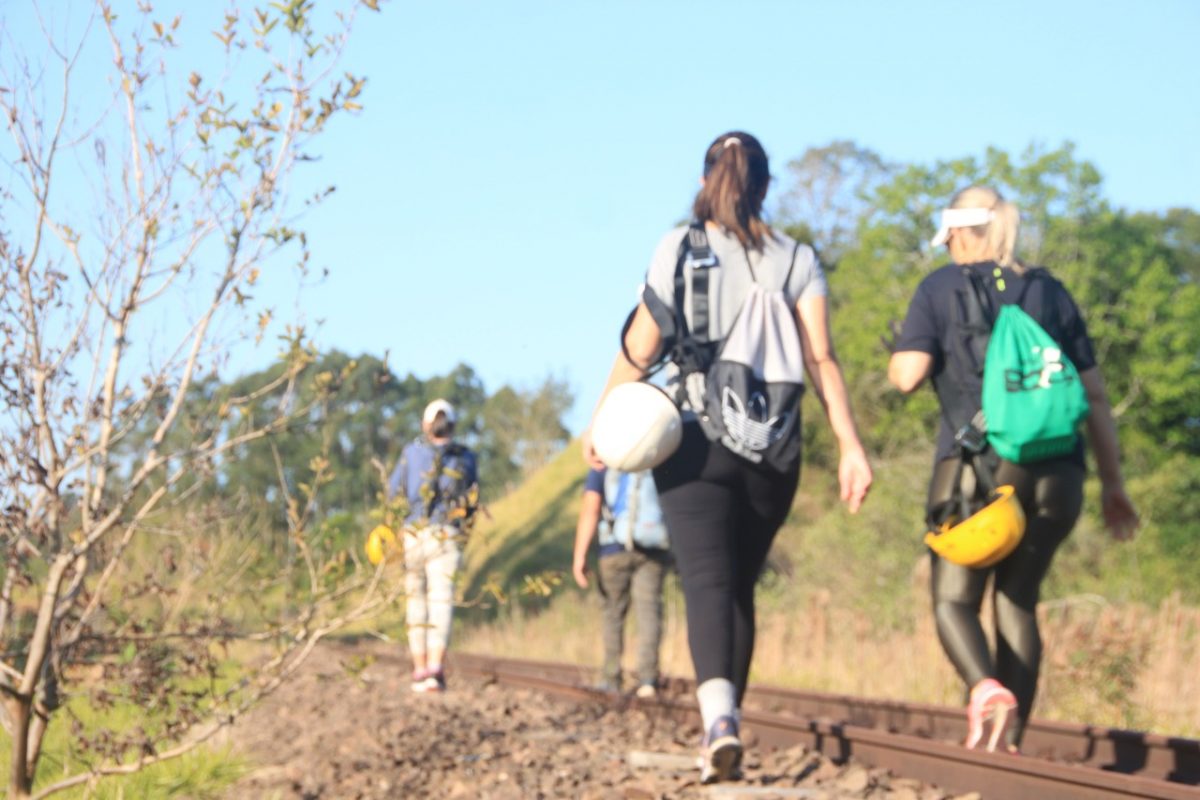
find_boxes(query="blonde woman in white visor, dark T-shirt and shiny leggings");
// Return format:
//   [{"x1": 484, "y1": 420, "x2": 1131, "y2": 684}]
[{"x1": 888, "y1": 186, "x2": 1138, "y2": 753}]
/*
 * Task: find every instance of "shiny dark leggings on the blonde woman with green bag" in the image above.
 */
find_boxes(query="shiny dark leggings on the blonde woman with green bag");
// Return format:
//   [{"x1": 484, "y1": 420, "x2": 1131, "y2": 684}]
[{"x1": 929, "y1": 459, "x2": 1084, "y2": 746}]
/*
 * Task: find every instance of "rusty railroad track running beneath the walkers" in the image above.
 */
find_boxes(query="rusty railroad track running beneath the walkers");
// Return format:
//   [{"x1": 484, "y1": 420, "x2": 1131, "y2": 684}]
[{"x1": 451, "y1": 654, "x2": 1200, "y2": 800}]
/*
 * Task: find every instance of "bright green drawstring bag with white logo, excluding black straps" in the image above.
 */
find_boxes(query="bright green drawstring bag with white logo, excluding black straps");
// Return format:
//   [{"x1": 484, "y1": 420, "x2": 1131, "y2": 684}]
[{"x1": 983, "y1": 305, "x2": 1087, "y2": 464}]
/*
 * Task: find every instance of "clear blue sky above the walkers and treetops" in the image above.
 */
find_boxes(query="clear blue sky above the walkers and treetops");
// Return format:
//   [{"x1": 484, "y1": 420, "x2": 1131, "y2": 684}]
[{"x1": 5, "y1": 0, "x2": 1200, "y2": 431}]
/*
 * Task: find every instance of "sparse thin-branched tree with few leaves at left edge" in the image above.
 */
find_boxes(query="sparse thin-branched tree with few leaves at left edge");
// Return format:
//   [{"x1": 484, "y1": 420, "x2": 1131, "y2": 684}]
[{"x1": 0, "y1": 0, "x2": 383, "y2": 798}]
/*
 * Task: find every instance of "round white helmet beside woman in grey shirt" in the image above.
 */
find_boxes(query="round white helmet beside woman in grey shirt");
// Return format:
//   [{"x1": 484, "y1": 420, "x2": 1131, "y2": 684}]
[{"x1": 592, "y1": 381, "x2": 683, "y2": 473}]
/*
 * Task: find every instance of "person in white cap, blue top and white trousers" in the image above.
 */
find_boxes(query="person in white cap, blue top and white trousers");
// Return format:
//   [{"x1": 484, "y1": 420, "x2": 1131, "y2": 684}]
[{"x1": 388, "y1": 398, "x2": 479, "y2": 692}]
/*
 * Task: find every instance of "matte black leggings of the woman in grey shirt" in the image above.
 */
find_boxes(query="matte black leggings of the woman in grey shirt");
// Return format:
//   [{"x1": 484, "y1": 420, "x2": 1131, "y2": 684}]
[{"x1": 654, "y1": 423, "x2": 800, "y2": 706}]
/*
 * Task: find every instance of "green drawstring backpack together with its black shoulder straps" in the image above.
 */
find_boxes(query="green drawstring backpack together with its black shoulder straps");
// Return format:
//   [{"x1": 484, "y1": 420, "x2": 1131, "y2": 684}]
[{"x1": 946, "y1": 267, "x2": 1088, "y2": 464}]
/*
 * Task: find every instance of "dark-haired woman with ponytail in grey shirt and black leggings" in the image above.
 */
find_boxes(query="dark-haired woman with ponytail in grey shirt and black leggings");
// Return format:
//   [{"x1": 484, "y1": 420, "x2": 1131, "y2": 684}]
[{"x1": 584, "y1": 131, "x2": 871, "y2": 783}]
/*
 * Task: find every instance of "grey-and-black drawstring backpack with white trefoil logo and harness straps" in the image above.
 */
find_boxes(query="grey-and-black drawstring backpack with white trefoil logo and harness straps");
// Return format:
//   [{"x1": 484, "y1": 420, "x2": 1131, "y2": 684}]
[{"x1": 622, "y1": 222, "x2": 804, "y2": 471}]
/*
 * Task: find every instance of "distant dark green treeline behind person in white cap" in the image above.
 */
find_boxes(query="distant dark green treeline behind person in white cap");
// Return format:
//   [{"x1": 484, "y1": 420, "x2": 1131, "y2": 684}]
[{"x1": 207, "y1": 351, "x2": 572, "y2": 525}]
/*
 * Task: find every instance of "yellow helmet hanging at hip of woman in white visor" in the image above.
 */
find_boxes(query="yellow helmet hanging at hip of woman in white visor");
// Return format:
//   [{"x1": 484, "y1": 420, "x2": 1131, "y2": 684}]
[{"x1": 925, "y1": 486, "x2": 1025, "y2": 567}]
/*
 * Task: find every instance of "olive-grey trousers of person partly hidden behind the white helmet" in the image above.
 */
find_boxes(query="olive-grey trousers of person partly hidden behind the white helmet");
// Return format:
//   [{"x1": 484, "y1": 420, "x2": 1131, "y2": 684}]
[{"x1": 599, "y1": 549, "x2": 670, "y2": 688}]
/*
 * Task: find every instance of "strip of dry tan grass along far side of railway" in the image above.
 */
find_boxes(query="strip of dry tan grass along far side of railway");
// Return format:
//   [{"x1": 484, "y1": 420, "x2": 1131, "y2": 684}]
[{"x1": 457, "y1": 575, "x2": 1200, "y2": 736}]
